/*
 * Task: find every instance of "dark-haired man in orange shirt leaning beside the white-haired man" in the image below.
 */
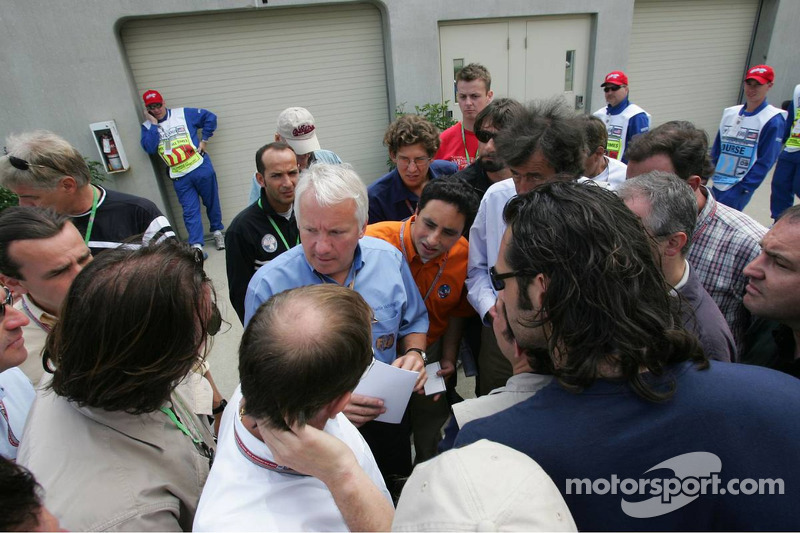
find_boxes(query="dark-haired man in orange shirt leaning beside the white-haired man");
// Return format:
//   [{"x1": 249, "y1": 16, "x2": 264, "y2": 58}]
[{"x1": 366, "y1": 178, "x2": 478, "y2": 463}]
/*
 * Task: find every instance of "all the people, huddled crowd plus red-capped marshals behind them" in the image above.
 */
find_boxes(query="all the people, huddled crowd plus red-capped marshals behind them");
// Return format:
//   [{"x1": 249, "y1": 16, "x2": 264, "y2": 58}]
[{"x1": 0, "y1": 64, "x2": 800, "y2": 531}]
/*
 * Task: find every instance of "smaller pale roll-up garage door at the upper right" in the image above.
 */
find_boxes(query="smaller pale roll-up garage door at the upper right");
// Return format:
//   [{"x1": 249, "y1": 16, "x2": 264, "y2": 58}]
[{"x1": 627, "y1": 0, "x2": 758, "y2": 139}]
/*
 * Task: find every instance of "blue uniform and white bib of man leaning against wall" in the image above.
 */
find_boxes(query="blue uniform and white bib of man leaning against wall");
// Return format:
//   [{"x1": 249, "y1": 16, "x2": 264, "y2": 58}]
[{"x1": 141, "y1": 107, "x2": 224, "y2": 245}]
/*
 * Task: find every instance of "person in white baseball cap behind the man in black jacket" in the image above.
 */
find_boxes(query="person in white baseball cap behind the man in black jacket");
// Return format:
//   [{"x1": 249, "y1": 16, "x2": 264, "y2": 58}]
[{"x1": 250, "y1": 107, "x2": 342, "y2": 203}]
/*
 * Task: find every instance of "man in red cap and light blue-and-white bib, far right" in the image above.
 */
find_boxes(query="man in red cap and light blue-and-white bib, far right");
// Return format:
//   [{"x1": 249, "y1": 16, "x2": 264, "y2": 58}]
[{"x1": 711, "y1": 65, "x2": 786, "y2": 211}]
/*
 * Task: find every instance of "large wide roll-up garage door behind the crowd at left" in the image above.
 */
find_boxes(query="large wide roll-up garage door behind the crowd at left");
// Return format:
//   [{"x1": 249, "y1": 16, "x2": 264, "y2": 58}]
[{"x1": 121, "y1": 4, "x2": 390, "y2": 237}]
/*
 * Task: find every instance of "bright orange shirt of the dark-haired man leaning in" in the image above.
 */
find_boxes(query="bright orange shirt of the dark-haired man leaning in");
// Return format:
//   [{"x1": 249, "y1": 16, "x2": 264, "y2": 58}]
[{"x1": 366, "y1": 216, "x2": 475, "y2": 346}]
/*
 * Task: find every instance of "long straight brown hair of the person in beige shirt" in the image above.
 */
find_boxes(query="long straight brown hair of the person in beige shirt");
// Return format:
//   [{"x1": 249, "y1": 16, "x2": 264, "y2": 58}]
[{"x1": 45, "y1": 239, "x2": 215, "y2": 414}]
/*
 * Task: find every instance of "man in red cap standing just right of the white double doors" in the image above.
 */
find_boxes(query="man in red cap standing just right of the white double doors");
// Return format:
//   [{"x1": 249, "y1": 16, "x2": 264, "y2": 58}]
[{"x1": 594, "y1": 70, "x2": 650, "y2": 164}]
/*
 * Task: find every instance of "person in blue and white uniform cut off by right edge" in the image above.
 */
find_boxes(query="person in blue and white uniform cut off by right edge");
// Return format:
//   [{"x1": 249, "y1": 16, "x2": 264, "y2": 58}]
[{"x1": 769, "y1": 85, "x2": 800, "y2": 220}]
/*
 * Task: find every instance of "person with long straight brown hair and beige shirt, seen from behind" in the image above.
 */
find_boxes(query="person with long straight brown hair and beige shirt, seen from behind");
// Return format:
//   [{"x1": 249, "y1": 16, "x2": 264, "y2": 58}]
[{"x1": 19, "y1": 240, "x2": 219, "y2": 531}]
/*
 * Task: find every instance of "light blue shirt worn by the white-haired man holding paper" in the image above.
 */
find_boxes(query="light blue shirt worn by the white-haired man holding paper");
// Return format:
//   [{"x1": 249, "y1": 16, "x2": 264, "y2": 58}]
[{"x1": 244, "y1": 237, "x2": 428, "y2": 363}]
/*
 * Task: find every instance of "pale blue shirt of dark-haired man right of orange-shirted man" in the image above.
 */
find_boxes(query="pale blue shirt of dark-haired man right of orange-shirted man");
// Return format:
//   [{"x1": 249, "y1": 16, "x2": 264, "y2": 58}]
[{"x1": 467, "y1": 178, "x2": 517, "y2": 319}]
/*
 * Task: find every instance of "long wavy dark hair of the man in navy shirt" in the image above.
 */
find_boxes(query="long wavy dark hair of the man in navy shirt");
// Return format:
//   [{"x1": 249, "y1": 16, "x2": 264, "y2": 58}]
[{"x1": 503, "y1": 181, "x2": 708, "y2": 401}]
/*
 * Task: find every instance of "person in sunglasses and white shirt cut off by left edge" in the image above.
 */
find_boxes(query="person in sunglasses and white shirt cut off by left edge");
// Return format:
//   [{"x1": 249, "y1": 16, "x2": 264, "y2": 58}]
[{"x1": 0, "y1": 286, "x2": 35, "y2": 461}]
